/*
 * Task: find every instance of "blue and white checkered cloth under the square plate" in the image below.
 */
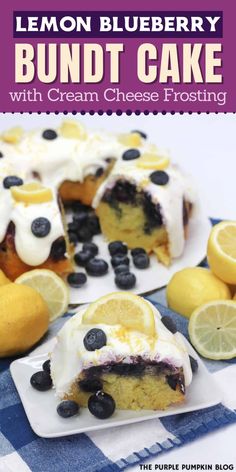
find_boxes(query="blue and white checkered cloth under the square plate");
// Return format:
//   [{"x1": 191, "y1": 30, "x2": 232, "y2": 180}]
[{"x1": 0, "y1": 219, "x2": 236, "y2": 472}]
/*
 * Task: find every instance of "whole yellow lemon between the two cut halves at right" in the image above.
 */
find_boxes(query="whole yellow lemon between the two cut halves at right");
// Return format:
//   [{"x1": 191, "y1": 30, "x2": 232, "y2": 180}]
[{"x1": 166, "y1": 267, "x2": 232, "y2": 318}]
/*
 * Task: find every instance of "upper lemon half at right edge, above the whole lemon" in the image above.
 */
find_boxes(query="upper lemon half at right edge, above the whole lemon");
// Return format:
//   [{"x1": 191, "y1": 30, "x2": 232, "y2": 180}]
[{"x1": 207, "y1": 221, "x2": 236, "y2": 284}]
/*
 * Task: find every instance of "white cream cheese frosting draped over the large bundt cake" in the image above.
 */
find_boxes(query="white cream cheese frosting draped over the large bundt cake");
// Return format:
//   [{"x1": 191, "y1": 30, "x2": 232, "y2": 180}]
[{"x1": 0, "y1": 121, "x2": 195, "y2": 266}]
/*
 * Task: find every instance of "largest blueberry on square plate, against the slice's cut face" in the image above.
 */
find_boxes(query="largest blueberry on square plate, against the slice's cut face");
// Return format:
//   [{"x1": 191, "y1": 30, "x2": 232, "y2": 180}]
[{"x1": 88, "y1": 390, "x2": 116, "y2": 420}]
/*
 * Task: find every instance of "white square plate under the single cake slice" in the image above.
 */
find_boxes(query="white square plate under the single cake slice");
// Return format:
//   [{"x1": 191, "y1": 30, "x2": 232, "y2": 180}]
[{"x1": 10, "y1": 338, "x2": 222, "y2": 438}]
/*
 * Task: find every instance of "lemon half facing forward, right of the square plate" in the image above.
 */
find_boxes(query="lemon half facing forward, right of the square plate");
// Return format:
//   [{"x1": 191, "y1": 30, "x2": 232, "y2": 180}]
[{"x1": 188, "y1": 300, "x2": 236, "y2": 360}]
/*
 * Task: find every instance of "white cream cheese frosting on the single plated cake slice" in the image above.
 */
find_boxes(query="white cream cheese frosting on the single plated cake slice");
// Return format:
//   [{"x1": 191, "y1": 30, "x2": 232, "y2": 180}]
[{"x1": 50, "y1": 305, "x2": 192, "y2": 398}]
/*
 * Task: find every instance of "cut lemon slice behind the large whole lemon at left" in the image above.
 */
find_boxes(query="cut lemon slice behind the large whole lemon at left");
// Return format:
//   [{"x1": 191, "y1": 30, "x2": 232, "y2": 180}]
[{"x1": 15, "y1": 269, "x2": 69, "y2": 321}]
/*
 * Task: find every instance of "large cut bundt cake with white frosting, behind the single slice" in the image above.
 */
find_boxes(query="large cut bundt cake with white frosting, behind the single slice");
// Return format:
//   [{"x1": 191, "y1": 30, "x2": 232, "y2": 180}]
[{"x1": 0, "y1": 121, "x2": 194, "y2": 280}]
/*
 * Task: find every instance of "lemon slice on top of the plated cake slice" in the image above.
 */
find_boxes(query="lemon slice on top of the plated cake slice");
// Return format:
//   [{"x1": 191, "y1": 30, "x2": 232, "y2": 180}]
[{"x1": 83, "y1": 292, "x2": 155, "y2": 336}]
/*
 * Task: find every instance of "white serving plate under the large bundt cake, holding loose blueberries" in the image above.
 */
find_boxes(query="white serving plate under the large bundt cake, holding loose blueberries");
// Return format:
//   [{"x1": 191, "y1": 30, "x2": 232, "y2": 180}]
[{"x1": 70, "y1": 211, "x2": 211, "y2": 304}]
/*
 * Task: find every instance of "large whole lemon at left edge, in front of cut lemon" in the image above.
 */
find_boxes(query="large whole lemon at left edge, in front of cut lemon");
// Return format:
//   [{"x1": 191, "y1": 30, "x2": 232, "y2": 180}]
[{"x1": 0, "y1": 283, "x2": 49, "y2": 357}]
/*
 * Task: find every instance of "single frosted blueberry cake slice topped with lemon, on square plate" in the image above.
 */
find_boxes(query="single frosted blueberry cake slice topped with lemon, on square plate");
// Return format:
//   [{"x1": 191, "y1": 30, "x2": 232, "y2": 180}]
[{"x1": 51, "y1": 292, "x2": 192, "y2": 410}]
